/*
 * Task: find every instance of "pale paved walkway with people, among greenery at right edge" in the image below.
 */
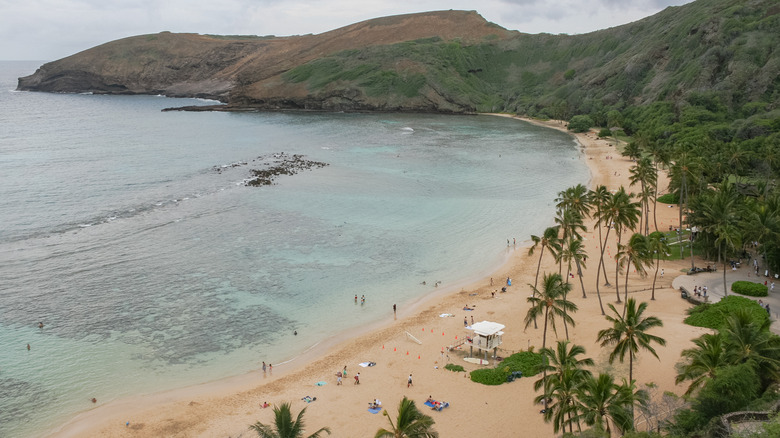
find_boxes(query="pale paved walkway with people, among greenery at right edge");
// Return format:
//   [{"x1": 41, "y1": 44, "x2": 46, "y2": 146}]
[{"x1": 672, "y1": 265, "x2": 780, "y2": 334}]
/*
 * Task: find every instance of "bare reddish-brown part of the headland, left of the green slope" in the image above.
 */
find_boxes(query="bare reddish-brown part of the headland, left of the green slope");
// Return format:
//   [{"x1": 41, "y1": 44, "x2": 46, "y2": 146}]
[{"x1": 18, "y1": 11, "x2": 515, "y2": 112}]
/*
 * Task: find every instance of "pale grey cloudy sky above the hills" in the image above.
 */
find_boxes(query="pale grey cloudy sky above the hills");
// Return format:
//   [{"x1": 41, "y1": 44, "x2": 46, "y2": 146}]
[{"x1": 0, "y1": 0, "x2": 691, "y2": 61}]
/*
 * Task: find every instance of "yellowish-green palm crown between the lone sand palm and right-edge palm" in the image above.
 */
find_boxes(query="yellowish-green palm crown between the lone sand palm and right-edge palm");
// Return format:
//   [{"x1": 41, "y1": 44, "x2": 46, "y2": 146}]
[{"x1": 674, "y1": 333, "x2": 728, "y2": 395}]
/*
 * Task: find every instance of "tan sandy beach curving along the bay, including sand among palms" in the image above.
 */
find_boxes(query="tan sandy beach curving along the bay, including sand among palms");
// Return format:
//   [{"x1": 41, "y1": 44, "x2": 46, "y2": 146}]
[{"x1": 52, "y1": 116, "x2": 708, "y2": 437}]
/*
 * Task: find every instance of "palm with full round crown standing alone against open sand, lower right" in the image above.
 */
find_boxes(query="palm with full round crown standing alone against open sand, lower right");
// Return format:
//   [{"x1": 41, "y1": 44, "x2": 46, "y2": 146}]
[{"x1": 596, "y1": 298, "x2": 666, "y2": 382}]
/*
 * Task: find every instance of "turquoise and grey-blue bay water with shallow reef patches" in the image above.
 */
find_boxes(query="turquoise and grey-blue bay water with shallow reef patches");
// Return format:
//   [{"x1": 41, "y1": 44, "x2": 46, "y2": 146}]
[{"x1": 0, "y1": 61, "x2": 589, "y2": 438}]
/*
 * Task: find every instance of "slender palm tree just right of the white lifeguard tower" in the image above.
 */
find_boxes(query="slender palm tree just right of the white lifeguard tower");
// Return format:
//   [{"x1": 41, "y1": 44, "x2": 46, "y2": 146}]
[{"x1": 525, "y1": 273, "x2": 577, "y2": 409}]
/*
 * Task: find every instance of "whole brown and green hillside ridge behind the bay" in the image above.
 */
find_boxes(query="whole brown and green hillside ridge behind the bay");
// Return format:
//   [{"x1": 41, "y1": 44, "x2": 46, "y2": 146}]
[{"x1": 19, "y1": 0, "x2": 780, "y2": 118}]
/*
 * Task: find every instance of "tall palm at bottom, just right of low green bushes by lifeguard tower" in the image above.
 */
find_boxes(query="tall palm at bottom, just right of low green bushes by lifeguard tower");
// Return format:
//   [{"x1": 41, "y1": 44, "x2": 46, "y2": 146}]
[{"x1": 534, "y1": 341, "x2": 593, "y2": 433}]
